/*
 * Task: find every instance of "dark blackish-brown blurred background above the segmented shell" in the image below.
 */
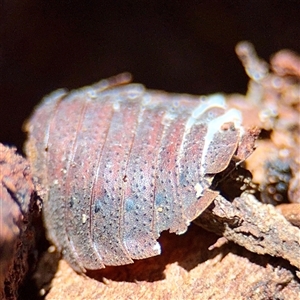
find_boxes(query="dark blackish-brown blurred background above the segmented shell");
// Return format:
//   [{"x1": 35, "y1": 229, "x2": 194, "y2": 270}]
[{"x1": 0, "y1": 0, "x2": 300, "y2": 152}]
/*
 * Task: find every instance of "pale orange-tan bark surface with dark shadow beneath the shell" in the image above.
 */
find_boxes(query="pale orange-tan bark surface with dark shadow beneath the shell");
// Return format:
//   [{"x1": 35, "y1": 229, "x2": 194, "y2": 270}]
[{"x1": 46, "y1": 225, "x2": 300, "y2": 300}]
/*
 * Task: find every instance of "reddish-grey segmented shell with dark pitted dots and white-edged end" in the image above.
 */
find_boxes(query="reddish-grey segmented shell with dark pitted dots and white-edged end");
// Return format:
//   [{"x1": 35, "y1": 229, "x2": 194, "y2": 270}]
[{"x1": 26, "y1": 77, "x2": 243, "y2": 272}]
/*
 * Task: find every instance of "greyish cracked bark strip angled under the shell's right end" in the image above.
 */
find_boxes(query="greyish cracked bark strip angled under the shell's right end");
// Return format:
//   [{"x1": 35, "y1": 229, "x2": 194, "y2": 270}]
[{"x1": 196, "y1": 193, "x2": 300, "y2": 269}]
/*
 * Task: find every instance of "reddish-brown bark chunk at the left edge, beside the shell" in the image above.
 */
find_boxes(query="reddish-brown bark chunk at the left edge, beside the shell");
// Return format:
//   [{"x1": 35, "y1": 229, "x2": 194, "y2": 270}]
[{"x1": 0, "y1": 144, "x2": 35, "y2": 299}]
